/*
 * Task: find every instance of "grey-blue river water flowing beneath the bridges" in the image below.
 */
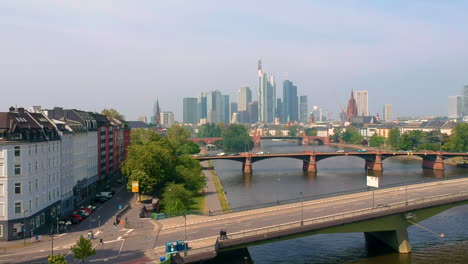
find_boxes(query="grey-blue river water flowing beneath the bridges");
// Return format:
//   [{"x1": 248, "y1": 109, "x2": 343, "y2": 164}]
[{"x1": 209, "y1": 140, "x2": 468, "y2": 264}]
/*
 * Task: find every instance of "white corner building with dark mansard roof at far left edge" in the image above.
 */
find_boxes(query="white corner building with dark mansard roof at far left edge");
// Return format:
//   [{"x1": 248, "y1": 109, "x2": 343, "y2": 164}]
[{"x1": 0, "y1": 108, "x2": 61, "y2": 240}]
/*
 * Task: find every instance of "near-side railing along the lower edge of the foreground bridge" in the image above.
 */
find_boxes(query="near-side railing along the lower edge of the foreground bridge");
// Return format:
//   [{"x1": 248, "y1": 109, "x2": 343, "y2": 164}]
[{"x1": 220, "y1": 191, "x2": 468, "y2": 242}]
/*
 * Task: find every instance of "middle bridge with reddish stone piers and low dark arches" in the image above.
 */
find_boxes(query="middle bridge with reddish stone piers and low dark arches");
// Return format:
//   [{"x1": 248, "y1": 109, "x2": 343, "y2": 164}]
[{"x1": 194, "y1": 151, "x2": 468, "y2": 173}]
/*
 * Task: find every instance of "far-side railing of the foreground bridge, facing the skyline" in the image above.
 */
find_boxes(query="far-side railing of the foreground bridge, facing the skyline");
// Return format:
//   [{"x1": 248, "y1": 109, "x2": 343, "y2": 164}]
[{"x1": 209, "y1": 173, "x2": 466, "y2": 215}]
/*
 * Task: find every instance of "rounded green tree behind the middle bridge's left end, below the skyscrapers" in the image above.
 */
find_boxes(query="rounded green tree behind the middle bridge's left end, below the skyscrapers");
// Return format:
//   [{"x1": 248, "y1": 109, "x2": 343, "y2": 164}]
[{"x1": 222, "y1": 124, "x2": 253, "y2": 151}]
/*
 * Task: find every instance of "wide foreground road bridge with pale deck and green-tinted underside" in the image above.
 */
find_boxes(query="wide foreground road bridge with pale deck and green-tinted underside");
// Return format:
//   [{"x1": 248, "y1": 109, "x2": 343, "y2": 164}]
[{"x1": 155, "y1": 179, "x2": 468, "y2": 263}]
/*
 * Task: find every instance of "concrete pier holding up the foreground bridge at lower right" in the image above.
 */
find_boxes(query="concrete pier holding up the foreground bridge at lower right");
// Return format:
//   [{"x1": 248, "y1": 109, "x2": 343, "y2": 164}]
[{"x1": 364, "y1": 228, "x2": 411, "y2": 254}]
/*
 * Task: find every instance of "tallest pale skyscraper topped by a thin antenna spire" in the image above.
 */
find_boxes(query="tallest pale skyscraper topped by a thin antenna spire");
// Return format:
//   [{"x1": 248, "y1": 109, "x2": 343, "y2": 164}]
[{"x1": 258, "y1": 60, "x2": 276, "y2": 123}]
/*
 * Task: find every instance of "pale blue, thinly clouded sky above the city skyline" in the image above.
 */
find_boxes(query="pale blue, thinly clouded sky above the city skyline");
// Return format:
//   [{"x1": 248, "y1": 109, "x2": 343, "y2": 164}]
[{"x1": 0, "y1": 0, "x2": 468, "y2": 121}]
